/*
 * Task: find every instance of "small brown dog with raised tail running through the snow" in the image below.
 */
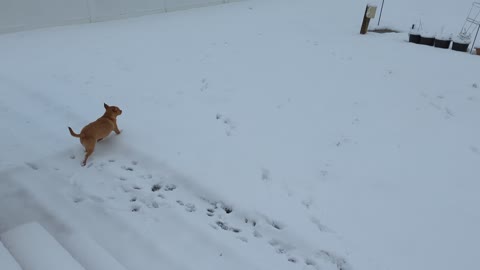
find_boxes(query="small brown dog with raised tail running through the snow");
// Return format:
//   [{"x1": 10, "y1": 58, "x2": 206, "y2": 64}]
[{"x1": 68, "y1": 103, "x2": 122, "y2": 166}]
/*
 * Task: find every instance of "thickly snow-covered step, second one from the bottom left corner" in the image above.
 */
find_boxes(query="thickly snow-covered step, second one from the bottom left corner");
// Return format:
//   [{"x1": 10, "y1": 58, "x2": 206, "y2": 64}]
[{"x1": 0, "y1": 223, "x2": 85, "y2": 270}]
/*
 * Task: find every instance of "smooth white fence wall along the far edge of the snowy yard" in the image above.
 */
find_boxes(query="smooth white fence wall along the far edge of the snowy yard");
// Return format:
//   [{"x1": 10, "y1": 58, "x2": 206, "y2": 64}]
[{"x1": 0, "y1": 0, "x2": 234, "y2": 33}]
